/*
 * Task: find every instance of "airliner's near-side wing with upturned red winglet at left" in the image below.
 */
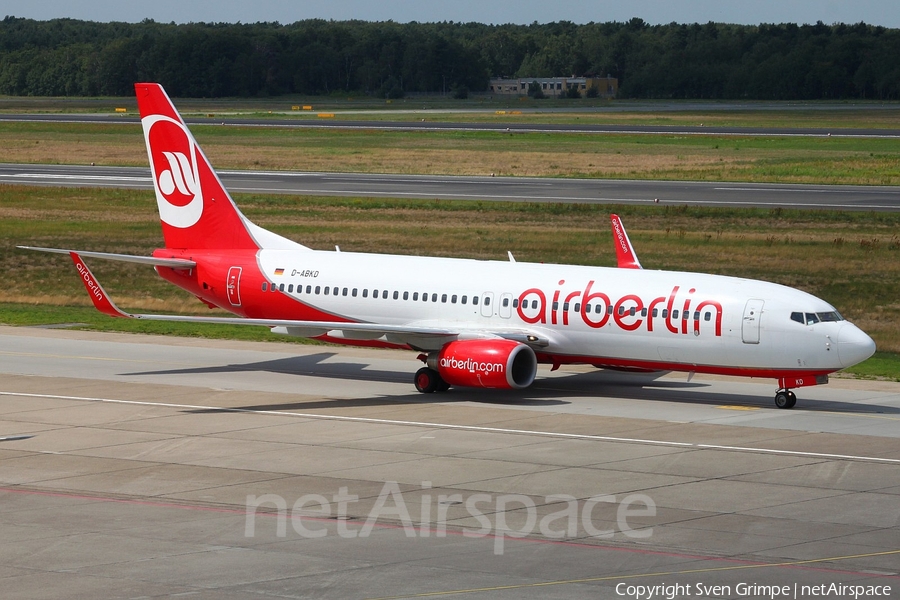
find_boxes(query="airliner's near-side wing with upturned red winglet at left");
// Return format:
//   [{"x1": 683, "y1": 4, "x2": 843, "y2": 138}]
[{"x1": 65, "y1": 250, "x2": 550, "y2": 347}]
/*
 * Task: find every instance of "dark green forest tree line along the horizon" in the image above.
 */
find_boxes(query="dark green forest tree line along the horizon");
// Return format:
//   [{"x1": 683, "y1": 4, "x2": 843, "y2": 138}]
[{"x1": 0, "y1": 17, "x2": 900, "y2": 100}]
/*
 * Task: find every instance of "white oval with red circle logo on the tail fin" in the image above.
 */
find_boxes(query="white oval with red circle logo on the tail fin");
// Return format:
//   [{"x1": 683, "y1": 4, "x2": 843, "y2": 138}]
[{"x1": 142, "y1": 115, "x2": 203, "y2": 229}]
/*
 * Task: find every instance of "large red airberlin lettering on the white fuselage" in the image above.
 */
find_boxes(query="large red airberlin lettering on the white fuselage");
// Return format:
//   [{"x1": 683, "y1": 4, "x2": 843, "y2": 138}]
[{"x1": 516, "y1": 280, "x2": 722, "y2": 337}]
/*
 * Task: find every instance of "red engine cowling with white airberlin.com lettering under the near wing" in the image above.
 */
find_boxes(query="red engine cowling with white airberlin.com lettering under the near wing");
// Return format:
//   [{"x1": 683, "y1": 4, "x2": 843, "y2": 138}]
[{"x1": 428, "y1": 339, "x2": 537, "y2": 390}]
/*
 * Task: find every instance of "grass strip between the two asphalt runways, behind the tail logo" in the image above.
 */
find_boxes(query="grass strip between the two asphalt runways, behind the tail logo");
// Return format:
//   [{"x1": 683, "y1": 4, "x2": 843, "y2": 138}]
[{"x1": 0, "y1": 122, "x2": 900, "y2": 185}]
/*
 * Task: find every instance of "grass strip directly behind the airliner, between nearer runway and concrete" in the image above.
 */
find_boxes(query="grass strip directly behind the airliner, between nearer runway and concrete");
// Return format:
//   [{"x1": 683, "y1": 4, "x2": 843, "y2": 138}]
[{"x1": 0, "y1": 186, "x2": 900, "y2": 377}]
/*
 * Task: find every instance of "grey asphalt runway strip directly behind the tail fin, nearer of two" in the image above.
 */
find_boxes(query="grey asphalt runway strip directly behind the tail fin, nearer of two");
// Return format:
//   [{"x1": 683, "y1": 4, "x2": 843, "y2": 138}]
[{"x1": 0, "y1": 164, "x2": 900, "y2": 211}]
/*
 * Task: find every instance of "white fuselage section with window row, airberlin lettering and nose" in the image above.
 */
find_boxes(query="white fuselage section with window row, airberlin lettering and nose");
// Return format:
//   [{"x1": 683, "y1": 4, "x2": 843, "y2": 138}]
[{"x1": 258, "y1": 249, "x2": 872, "y2": 376}]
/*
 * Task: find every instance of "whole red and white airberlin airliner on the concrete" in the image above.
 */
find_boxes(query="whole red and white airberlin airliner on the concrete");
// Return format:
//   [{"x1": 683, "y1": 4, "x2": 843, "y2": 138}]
[{"x1": 25, "y1": 83, "x2": 875, "y2": 408}]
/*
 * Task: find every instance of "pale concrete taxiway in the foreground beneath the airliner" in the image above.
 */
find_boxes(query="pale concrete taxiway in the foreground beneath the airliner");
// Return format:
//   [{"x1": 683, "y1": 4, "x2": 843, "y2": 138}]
[{"x1": 0, "y1": 327, "x2": 900, "y2": 598}]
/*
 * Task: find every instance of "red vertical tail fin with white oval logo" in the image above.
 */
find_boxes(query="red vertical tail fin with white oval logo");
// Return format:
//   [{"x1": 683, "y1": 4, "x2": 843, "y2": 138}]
[{"x1": 134, "y1": 83, "x2": 259, "y2": 249}]
